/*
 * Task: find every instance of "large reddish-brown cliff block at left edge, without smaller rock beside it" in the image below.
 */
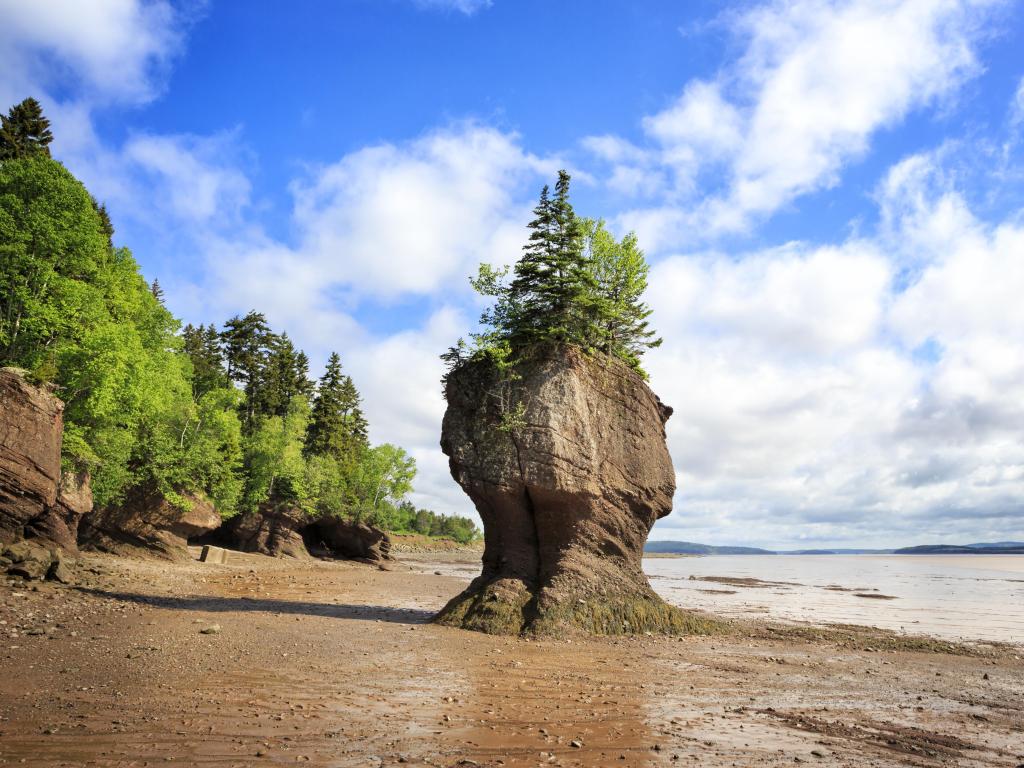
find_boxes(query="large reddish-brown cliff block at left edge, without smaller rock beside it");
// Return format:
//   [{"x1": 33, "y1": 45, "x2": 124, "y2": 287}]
[{"x1": 0, "y1": 368, "x2": 63, "y2": 544}]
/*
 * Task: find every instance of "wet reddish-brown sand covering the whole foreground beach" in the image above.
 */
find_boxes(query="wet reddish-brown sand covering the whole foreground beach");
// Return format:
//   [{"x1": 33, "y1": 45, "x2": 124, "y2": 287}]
[{"x1": 0, "y1": 553, "x2": 1024, "y2": 768}]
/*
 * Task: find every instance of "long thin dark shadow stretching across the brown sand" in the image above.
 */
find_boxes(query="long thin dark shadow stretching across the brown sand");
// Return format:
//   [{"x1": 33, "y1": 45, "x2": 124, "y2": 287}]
[{"x1": 75, "y1": 587, "x2": 434, "y2": 624}]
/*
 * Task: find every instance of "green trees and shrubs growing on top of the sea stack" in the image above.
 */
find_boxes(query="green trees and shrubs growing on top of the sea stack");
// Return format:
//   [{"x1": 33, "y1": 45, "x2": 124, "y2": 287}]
[{"x1": 441, "y1": 171, "x2": 662, "y2": 382}]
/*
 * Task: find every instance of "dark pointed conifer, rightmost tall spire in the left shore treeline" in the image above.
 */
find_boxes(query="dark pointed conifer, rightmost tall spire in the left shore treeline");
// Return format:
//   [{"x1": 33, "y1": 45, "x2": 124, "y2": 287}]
[{"x1": 305, "y1": 352, "x2": 369, "y2": 461}]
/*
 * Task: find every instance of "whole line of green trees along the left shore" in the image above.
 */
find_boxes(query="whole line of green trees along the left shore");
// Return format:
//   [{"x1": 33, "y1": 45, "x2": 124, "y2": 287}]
[{"x1": 0, "y1": 99, "x2": 476, "y2": 539}]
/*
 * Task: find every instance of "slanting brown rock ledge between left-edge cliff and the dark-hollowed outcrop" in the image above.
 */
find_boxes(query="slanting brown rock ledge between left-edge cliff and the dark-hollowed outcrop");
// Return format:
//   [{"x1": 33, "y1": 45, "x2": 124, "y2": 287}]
[{"x1": 79, "y1": 493, "x2": 221, "y2": 560}]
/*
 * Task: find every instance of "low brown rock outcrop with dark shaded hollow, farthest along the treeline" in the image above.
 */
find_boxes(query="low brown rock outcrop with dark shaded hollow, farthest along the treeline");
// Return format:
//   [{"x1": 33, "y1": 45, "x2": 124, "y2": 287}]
[{"x1": 222, "y1": 504, "x2": 391, "y2": 563}]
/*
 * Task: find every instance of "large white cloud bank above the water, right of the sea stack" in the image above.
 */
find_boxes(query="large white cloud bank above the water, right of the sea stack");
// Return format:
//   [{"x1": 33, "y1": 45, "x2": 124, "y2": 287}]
[{"x1": 649, "y1": 155, "x2": 1024, "y2": 546}]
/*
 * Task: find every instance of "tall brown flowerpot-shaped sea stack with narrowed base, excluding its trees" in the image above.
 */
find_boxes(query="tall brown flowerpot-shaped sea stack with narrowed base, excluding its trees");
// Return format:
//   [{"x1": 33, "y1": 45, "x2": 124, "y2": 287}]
[{"x1": 437, "y1": 348, "x2": 713, "y2": 634}]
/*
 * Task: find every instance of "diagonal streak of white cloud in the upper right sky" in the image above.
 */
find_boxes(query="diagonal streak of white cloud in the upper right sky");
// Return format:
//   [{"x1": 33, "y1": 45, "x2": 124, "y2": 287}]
[{"x1": 585, "y1": 0, "x2": 995, "y2": 248}]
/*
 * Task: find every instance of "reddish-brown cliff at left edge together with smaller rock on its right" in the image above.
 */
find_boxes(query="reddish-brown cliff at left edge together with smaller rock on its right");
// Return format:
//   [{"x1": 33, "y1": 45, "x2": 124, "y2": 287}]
[{"x1": 0, "y1": 368, "x2": 92, "y2": 555}]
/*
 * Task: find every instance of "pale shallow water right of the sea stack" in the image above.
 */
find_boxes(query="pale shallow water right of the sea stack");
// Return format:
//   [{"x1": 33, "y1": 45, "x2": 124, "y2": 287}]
[{"x1": 643, "y1": 555, "x2": 1024, "y2": 645}]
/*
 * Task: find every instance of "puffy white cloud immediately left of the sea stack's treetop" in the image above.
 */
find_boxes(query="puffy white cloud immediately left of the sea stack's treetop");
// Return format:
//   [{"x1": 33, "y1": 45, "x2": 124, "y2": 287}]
[{"x1": 284, "y1": 124, "x2": 544, "y2": 299}]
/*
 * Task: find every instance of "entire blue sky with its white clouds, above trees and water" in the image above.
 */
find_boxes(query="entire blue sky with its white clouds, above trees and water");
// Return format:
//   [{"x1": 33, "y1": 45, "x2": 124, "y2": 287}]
[{"x1": 0, "y1": 0, "x2": 1024, "y2": 547}]
